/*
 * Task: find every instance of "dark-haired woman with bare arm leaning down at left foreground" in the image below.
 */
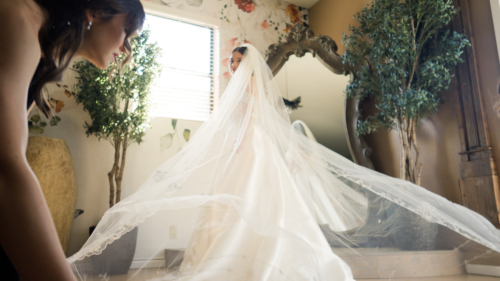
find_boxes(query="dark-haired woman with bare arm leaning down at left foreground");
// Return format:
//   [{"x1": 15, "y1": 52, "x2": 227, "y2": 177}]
[{"x1": 0, "y1": 0, "x2": 145, "y2": 281}]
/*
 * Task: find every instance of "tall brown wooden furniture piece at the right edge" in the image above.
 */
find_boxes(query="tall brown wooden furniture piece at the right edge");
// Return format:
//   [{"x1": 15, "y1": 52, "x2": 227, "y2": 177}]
[{"x1": 452, "y1": 0, "x2": 500, "y2": 227}]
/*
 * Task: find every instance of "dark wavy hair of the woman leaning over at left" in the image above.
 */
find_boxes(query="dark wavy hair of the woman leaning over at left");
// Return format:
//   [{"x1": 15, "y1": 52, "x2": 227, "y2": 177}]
[{"x1": 28, "y1": 0, "x2": 146, "y2": 117}]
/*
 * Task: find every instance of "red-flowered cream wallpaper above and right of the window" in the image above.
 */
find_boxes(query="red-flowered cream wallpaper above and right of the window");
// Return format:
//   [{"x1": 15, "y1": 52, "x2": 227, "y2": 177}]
[{"x1": 146, "y1": 0, "x2": 308, "y2": 86}]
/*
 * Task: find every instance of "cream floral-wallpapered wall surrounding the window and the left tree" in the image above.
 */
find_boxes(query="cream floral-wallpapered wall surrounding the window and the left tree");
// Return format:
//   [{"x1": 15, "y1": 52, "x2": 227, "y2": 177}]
[{"x1": 25, "y1": 0, "x2": 308, "y2": 255}]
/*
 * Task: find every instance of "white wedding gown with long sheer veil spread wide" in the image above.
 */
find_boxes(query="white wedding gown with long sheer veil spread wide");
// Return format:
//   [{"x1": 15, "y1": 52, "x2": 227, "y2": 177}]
[{"x1": 68, "y1": 45, "x2": 500, "y2": 281}]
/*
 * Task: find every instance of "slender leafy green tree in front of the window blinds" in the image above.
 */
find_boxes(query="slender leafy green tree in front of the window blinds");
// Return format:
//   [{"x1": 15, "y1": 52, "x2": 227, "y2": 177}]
[{"x1": 73, "y1": 29, "x2": 161, "y2": 207}]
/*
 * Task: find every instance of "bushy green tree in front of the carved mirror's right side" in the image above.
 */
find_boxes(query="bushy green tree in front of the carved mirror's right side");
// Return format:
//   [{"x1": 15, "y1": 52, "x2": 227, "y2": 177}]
[{"x1": 343, "y1": 0, "x2": 469, "y2": 185}]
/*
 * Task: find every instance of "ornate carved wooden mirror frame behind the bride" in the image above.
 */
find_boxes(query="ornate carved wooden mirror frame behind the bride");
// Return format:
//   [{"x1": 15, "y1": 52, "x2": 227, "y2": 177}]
[{"x1": 266, "y1": 23, "x2": 374, "y2": 169}]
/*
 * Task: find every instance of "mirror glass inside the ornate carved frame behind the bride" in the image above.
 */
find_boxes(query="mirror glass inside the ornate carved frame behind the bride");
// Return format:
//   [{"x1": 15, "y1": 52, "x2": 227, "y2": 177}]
[{"x1": 275, "y1": 53, "x2": 352, "y2": 159}]
